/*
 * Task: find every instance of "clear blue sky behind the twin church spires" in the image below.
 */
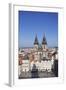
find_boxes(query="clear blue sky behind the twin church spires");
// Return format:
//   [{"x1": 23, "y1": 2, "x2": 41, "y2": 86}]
[{"x1": 18, "y1": 11, "x2": 58, "y2": 47}]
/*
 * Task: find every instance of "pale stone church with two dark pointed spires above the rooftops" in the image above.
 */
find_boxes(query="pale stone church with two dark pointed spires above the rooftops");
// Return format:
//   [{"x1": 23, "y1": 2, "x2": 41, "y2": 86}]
[{"x1": 34, "y1": 35, "x2": 48, "y2": 61}]
